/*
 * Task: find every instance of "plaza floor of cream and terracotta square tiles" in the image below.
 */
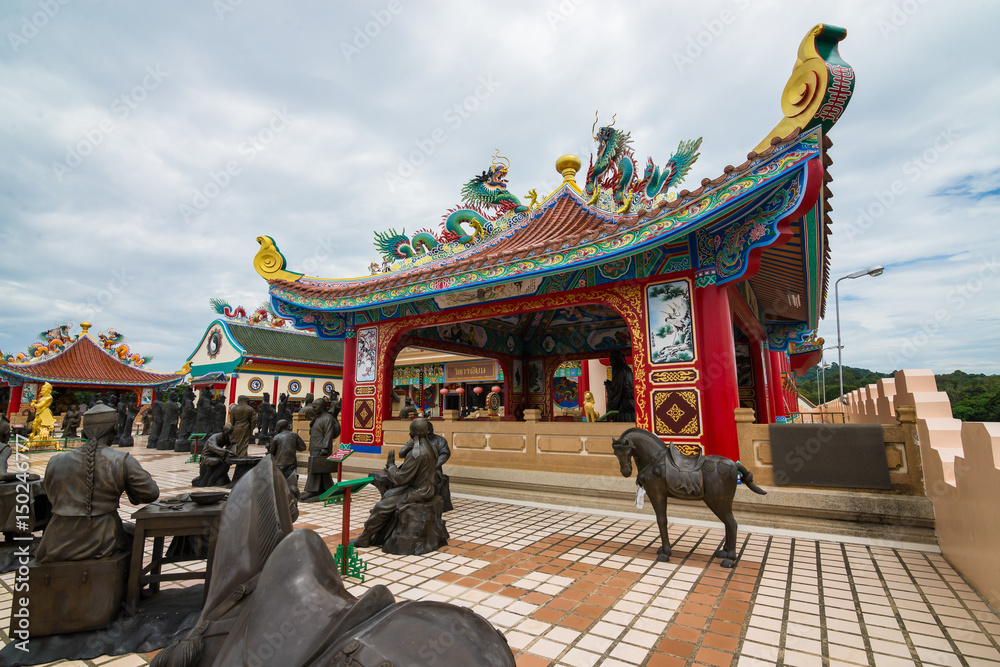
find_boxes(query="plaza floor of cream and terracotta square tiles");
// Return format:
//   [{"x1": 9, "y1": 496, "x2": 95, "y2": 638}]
[{"x1": 0, "y1": 447, "x2": 1000, "y2": 667}]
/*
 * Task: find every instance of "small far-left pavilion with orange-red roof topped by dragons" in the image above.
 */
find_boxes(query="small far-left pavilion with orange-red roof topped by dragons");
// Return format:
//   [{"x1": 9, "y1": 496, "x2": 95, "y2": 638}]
[{"x1": 0, "y1": 322, "x2": 185, "y2": 419}]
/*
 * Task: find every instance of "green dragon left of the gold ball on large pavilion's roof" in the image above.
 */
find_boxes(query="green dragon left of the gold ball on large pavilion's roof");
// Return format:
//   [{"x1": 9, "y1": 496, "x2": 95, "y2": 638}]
[{"x1": 375, "y1": 150, "x2": 534, "y2": 272}]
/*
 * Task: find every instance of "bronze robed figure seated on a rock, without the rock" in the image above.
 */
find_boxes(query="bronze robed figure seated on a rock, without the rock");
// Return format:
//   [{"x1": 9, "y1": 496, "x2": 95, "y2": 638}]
[{"x1": 354, "y1": 417, "x2": 438, "y2": 548}]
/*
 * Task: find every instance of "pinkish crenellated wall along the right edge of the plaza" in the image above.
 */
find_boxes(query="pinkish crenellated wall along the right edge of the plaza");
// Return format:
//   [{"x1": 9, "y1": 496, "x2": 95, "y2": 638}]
[{"x1": 828, "y1": 370, "x2": 1000, "y2": 609}]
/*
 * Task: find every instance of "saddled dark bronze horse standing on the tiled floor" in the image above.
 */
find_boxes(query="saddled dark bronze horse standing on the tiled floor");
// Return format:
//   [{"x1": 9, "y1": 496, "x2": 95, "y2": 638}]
[{"x1": 611, "y1": 428, "x2": 767, "y2": 567}]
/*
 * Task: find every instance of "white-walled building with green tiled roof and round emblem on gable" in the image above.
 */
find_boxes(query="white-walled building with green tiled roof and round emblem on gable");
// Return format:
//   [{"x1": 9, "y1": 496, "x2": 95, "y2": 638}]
[{"x1": 188, "y1": 308, "x2": 344, "y2": 406}]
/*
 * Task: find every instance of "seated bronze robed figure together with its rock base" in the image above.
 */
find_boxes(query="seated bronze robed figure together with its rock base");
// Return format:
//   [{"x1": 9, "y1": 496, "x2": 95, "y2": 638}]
[{"x1": 354, "y1": 418, "x2": 448, "y2": 556}]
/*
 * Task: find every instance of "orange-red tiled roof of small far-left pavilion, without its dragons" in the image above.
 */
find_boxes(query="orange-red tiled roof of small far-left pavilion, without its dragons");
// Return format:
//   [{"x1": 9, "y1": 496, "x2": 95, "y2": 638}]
[{"x1": 0, "y1": 333, "x2": 184, "y2": 387}]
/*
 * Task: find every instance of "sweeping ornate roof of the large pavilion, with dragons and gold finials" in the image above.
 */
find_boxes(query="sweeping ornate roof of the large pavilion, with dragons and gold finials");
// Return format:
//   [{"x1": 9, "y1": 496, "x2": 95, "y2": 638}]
[{"x1": 254, "y1": 24, "x2": 854, "y2": 338}]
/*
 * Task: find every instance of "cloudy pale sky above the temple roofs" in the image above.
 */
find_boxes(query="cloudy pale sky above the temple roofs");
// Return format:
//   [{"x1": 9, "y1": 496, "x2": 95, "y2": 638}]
[{"x1": 0, "y1": 0, "x2": 1000, "y2": 373}]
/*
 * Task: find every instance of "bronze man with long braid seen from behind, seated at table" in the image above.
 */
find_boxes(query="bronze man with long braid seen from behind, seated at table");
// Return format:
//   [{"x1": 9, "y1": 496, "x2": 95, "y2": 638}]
[{"x1": 35, "y1": 401, "x2": 160, "y2": 563}]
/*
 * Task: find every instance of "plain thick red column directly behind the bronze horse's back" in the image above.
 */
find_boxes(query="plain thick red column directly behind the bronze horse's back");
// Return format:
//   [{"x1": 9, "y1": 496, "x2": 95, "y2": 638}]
[{"x1": 694, "y1": 285, "x2": 740, "y2": 461}]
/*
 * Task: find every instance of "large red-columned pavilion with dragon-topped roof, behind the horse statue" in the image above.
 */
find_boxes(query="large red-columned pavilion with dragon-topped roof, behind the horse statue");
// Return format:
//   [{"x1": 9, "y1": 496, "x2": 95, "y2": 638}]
[{"x1": 246, "y1": 24, "x2": 854, "y2": 464}]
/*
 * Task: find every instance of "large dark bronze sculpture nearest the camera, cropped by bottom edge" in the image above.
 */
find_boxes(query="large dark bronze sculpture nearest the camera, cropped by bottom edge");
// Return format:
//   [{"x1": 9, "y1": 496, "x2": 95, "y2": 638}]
[{"x1": 158, "y1": 458, "x2": 515, "y2": 667}]
